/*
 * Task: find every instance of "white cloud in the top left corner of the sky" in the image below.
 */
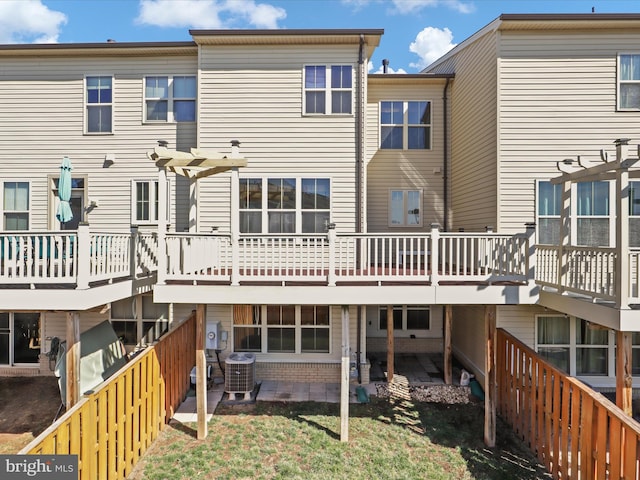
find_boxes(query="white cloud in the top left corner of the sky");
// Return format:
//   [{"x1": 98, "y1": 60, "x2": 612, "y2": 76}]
[{"x1": 0, "y1": 0, "x2": 67, "y2": 43}]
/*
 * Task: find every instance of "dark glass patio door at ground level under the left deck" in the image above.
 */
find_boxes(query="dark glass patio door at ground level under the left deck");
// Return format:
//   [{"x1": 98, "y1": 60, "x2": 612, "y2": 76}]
[{"x1": 0, "y1": 312, "x2": 41, "y2": 365}]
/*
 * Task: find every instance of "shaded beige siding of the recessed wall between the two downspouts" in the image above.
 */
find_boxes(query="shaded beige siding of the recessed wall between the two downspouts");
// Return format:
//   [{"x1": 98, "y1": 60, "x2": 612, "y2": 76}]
[{"x1": 365, "y1": 79, "x2": 444, "y2": 232}]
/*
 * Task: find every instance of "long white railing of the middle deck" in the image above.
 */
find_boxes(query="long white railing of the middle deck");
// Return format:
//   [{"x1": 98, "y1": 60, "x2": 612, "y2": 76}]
[{"x1": 158, "y1": 228, "x2": 532, "y2": 285}]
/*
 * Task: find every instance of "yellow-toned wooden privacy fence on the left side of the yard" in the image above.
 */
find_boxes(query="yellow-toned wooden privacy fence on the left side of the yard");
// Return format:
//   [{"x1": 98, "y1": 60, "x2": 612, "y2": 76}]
[{"x1": 19, "y1": 315, "x2": 195, "y2": 480}]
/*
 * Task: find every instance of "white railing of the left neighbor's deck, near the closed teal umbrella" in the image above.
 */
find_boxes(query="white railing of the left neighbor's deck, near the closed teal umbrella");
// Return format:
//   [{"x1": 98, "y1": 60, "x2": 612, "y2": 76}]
[{"x1": 0, "y1": 225, "x2": 158, "y2": 289}]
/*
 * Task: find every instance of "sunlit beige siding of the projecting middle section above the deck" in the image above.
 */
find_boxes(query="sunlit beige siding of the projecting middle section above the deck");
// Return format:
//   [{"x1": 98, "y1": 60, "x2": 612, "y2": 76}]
[{"x1": 199, "y1": 45, "x2": 358, "y2": 232}]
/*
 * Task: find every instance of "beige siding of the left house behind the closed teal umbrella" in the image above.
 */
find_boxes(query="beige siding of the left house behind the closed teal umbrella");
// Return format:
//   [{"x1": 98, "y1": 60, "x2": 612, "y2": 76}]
[{"x1": 0, "y1": 55, "x2": 197, "y2": 230}]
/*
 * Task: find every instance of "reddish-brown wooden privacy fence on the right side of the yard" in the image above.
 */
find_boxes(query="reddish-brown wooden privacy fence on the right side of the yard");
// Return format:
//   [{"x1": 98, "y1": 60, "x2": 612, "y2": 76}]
[{"x1": 496, "y1": 329, "x2": 640, "y2": 480}]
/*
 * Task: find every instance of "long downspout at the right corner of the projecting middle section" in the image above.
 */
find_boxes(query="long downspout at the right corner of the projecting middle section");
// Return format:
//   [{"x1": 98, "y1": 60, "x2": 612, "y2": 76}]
[{"x1": 356, "y1": 34, "x2": 364, "y2": 383}]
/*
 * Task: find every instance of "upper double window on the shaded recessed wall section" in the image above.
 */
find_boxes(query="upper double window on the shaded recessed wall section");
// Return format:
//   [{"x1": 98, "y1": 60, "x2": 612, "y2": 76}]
[{"x1": 380, "y1": 101, "x2": 431, "y2": 150}]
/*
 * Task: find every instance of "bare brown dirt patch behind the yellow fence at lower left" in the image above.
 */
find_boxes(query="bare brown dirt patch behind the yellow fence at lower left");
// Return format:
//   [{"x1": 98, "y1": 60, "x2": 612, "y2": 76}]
[{"x1": 0, "y1": 376, "x2": 61, "y2": 454}]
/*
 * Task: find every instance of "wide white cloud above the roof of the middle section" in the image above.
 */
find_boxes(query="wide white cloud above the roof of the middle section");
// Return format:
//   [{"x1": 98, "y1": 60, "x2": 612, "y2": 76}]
[{"x1": 136, "y1": 0, "x2": 287, "y2": 29}]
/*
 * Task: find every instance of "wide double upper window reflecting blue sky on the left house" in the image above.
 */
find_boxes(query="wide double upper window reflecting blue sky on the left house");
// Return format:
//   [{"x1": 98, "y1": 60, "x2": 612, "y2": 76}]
[{"x1": 144, "y1": 76, "x2": 196, "y2": 122}]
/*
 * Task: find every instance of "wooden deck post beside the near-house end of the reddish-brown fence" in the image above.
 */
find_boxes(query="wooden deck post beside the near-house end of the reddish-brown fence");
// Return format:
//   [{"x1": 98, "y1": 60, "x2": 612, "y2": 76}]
[{"x1": 484, "y1": 305, "x2": 497, "y2": 448}]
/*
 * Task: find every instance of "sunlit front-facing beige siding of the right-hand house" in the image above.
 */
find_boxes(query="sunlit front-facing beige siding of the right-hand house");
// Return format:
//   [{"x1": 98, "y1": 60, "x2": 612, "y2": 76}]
[{"x1": 499, "y1": 32, "x2": 640, "y2": 232}]
